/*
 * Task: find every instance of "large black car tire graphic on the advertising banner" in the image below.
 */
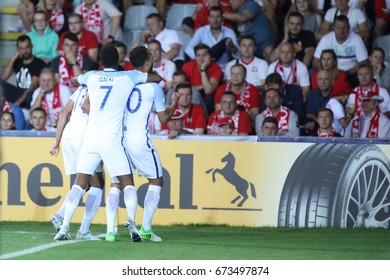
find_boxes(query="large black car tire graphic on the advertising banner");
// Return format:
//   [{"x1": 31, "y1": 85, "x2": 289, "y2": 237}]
[{"x1": 278, "y1": 144, "x2": 390, "y2": 229}]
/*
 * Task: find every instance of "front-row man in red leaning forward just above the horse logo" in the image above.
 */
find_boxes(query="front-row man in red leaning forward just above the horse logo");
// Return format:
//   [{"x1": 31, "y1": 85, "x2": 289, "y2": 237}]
[{"x1": 207, "y1": 91, "x2": 252, "y2": 135}]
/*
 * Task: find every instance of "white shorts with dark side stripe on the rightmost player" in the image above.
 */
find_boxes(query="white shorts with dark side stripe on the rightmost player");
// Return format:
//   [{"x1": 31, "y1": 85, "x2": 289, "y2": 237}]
[{"x1": 125, "y1": 132, "x2": 162, "y2": 179}]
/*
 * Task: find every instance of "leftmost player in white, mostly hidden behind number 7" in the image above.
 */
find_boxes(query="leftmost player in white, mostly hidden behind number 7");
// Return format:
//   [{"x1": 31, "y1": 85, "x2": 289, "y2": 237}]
[{"x1": 49, "y1": 86, "x2": 104, "y2": 240}]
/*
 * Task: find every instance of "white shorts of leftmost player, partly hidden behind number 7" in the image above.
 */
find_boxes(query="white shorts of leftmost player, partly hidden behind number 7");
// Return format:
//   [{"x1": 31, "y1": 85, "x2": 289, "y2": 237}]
[{"x1": 61, "y1": 138, "x2": 103, "y2": 175}]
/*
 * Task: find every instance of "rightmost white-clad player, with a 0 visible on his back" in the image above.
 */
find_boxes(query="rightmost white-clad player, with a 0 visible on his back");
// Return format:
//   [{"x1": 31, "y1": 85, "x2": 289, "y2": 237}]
[{"x1": 117, "y1": 45, "x2": 180, "y2": 242}]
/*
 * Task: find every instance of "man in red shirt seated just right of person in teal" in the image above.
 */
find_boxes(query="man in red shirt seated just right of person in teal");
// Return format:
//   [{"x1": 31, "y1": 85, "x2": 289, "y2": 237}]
[{"x1": 57, "y1": 14, "x2": 98, "y2": 62}]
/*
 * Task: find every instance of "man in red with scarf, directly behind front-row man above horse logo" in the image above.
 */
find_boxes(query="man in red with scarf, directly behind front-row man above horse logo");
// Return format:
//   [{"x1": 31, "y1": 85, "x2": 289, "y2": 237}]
[{"x1": 214, "y1": 64, "x2": 260, "y2": 120}]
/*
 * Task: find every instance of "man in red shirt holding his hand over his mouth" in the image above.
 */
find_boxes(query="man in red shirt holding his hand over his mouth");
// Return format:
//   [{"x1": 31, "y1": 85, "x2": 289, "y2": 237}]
[{"x1": 182, "y1": 44, "x2": 222, "y2": 114}]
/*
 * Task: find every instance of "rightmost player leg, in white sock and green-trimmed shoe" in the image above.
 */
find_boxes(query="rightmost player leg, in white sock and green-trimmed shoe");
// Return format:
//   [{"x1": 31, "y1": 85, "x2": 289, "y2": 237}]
[{"x1": 140, "y1": 177, "x2": 164, "y2": 242}]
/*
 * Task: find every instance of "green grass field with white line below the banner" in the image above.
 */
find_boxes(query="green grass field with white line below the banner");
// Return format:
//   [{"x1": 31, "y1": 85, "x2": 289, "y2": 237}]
[{"x1": 0, "y1": 222, "x2": 390, "y2": 260}]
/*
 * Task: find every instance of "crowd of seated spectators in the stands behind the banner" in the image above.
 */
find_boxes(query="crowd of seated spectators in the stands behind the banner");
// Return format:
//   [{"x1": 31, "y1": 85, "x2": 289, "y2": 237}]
[{"x1": 0, "y1": 0, "x2": 390, "y2": 138}]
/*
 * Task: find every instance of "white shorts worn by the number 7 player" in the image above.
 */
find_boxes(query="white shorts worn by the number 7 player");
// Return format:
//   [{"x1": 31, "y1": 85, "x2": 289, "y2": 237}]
[{"x1": 77, "y1": 134, "x2": 132, "y2": 177}]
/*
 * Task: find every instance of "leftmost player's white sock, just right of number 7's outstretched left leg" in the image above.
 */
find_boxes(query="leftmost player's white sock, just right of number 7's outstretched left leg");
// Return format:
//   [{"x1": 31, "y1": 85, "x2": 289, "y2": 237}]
[{"x1": 80, "y1": 187, "x2": 103, "y2": 234}]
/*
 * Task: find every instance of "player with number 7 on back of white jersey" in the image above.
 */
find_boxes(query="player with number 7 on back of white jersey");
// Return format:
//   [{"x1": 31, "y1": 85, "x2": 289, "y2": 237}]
[{"x1": 54, "y1": 44, "x2": 161, "y2": 240}]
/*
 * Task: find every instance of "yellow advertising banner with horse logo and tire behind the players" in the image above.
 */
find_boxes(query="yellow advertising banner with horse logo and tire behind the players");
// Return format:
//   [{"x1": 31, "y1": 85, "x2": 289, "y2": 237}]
[{"x1": 0, "y1": 137, "x2": 390, "y2": 228}]
